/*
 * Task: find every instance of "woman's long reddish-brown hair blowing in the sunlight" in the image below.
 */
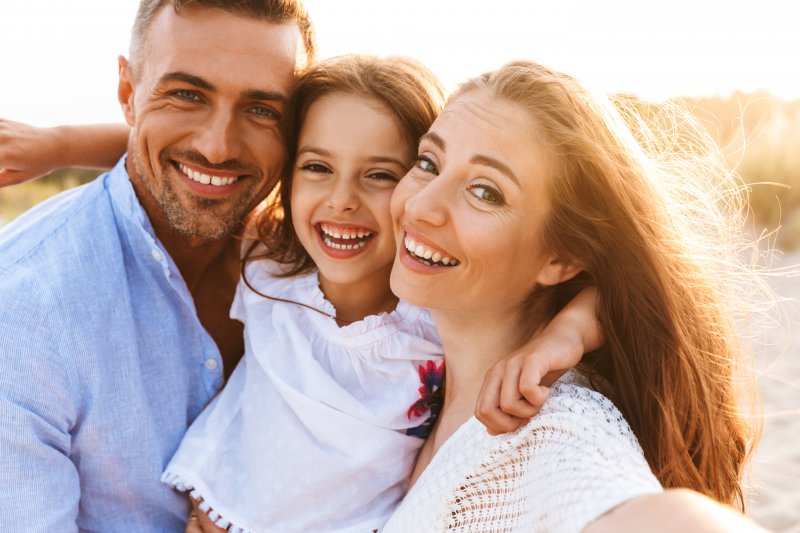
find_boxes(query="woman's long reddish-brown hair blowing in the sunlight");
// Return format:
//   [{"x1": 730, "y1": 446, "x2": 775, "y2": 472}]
[{"x1": 453, "y1": 61, "x2": 755, "y2": 506}]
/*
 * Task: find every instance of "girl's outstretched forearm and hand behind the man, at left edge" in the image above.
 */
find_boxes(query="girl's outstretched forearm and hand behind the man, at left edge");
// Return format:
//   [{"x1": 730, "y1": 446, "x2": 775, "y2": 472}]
[{"x1": 0, "y1": 119, "x2": 130, "y2": 187}]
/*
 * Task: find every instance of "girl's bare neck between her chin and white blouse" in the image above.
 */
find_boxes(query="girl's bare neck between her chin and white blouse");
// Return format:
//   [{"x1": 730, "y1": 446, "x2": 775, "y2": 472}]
[{"x1": 319, "y1": 265, "x2": 398, "y2": 326}]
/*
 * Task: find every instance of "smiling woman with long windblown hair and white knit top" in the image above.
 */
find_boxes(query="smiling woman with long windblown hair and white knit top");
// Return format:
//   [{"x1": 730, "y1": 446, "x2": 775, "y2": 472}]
[{"x1": 386, "y1": 62, "x2": 768, "y2": 532}]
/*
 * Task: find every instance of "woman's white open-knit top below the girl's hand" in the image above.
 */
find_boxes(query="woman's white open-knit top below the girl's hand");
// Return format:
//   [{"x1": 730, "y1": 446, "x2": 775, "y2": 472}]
[{"x1": 381, "y1": 371, "x2": 662, "y2": 533}]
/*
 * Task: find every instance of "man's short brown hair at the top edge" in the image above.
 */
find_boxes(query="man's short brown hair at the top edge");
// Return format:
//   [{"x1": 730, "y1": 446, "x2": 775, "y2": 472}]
[{"x1": 130, "y1": 0, "x2": 317, "y2": 70}]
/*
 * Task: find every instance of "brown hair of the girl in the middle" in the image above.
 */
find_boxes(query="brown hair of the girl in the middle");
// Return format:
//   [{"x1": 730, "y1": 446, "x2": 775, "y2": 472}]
[{"x1": 245, "y1": 55, "x2": 444, "y2": 276}]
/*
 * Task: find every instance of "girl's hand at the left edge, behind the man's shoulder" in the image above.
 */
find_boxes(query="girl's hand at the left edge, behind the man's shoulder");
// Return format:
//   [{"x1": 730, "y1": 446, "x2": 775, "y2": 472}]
[{"x1": 0, "y1": 118, "x2": 64, "y2": 187}]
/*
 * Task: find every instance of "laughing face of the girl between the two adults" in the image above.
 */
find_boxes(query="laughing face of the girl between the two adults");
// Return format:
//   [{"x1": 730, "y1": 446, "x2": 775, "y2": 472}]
[{"x1": 291, "y1": 93, "x2": 414, "y2": 300}]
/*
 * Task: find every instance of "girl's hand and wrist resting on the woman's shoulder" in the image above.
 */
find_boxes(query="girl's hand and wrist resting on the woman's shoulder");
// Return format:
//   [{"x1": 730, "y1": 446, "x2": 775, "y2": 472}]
[{"x1": 475, "y1": 287, "x2": 603, "y2": 435}]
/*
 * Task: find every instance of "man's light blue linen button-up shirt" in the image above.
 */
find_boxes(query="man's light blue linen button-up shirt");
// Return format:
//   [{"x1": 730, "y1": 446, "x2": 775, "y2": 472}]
[{"x1": 0, "y1": 158, "x2": 223, "y2": 533}]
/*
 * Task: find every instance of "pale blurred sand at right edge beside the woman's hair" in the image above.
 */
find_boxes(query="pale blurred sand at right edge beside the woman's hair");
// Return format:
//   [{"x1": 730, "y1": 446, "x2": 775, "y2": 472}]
[{"x1": 749, "y1": 252, "x2": 800, "y2": 533}]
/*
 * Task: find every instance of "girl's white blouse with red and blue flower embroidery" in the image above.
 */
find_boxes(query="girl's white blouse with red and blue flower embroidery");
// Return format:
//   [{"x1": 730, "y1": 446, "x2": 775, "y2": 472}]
[{"x1": 162, "y1": 261, "x2": 443, "y2": 533}]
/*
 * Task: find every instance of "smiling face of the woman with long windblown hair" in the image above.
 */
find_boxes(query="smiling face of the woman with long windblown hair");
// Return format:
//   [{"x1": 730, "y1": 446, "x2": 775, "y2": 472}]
[{"x1": 391, "y1": 91, "x2": 552, "y2": 313}]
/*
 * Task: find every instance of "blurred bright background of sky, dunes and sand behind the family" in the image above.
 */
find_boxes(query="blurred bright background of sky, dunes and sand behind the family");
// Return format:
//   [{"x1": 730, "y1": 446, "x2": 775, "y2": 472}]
[{"x1": 0, "y1": 0, "x2": 800, "y2": 533}]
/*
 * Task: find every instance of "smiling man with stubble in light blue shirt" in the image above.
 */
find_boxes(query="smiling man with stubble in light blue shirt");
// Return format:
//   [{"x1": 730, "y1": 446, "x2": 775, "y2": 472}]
[{"x1": 0, "y1": 0, "x2": 314, "y2": 532}]
